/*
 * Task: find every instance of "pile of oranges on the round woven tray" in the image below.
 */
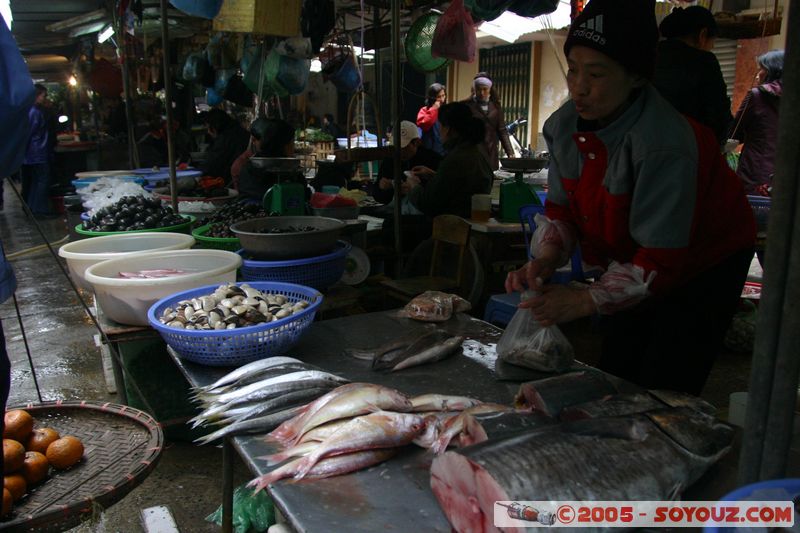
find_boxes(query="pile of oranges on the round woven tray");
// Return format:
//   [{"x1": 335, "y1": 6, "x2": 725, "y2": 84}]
[{"x1": 2, "y1": 409, "x2": 83, "y2": 516}]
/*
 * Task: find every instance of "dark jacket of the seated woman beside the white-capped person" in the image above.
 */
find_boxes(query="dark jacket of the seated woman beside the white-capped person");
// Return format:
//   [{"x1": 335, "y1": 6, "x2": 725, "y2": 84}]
[{"x1": 409, "y1": 142, "x2": 494, "y2": 218}]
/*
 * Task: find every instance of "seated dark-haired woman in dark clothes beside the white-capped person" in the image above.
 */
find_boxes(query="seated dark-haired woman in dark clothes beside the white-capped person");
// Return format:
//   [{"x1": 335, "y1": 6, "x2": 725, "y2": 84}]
[{"x1": 403, "y1": 102, "x2": 494, "y2": 218}]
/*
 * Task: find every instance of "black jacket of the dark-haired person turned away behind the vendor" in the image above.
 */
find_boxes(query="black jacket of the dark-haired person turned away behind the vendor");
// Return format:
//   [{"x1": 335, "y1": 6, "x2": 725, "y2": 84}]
[{"x1": 653, "y1": 39, "x2": 733, "y2": 145}]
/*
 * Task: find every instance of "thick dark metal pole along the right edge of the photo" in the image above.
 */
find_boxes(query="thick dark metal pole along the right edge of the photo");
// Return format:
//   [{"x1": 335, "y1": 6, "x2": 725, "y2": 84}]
[{"x1": 739, "y1": 0, "x2": 800, "y2": 485}]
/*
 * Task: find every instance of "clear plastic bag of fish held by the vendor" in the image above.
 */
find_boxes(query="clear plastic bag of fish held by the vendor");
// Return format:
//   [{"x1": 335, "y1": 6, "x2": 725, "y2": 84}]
[{"x1": 497, "y1": 291, "x2": 575, "y2": 372}]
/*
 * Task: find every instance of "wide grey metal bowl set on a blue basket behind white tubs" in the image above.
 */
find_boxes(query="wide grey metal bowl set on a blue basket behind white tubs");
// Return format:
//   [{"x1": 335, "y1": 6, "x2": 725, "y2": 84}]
[{"x1": 231, "y1": 216, "x2": 345, "y2": 261}]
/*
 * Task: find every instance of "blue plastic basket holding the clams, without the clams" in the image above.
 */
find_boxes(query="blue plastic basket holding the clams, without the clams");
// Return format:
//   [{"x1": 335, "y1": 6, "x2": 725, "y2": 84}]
[{"x1": 147, "y1": 281, "x2": 322, "y2": 366}]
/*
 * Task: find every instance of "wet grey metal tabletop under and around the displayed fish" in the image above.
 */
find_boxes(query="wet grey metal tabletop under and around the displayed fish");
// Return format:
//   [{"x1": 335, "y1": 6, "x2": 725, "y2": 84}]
[{"x1": 170, "y1": 310, "x2": 518, "y2": 532}]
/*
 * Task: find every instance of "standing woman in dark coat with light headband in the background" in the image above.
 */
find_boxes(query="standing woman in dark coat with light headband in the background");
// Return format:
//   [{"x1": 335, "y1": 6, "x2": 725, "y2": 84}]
[{"x1": 464, "y1": 72, "x2": 514, "y2": 170}]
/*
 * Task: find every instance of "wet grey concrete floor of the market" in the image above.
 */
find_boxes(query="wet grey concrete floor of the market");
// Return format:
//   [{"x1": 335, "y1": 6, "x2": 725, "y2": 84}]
[{"x1": 0, "y1": 177, "x2": 776, "y2": 533}]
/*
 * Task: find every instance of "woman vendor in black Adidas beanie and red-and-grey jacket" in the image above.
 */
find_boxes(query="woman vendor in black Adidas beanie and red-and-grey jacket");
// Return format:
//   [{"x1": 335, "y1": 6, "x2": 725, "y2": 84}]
[{"x1": 506, "y1": 0, "x2": 755, "y2": 394}]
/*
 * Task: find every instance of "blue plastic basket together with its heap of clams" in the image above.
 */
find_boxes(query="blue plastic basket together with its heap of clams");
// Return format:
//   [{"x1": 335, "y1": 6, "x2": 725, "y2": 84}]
[{"x1": 147, "y1": 281, "x2": 322, "y2": 366}]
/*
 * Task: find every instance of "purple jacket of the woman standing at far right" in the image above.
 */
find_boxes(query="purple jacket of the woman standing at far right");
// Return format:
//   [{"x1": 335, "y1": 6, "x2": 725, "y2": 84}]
[{"x1": 731, "y1": 80, "x2": 783, "y2": 194}]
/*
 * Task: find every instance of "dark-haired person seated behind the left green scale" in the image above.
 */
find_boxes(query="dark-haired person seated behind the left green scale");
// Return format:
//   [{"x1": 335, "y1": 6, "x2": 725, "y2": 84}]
[{"x1": 239, "y1": 118, "x2": 305, "y2": 203}]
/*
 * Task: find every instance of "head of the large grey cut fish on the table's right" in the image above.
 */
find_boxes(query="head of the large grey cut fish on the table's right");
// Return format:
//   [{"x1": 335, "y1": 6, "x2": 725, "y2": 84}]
[{"x1": 645, "y1": 407, "x2": 734, "y2": 460}]
